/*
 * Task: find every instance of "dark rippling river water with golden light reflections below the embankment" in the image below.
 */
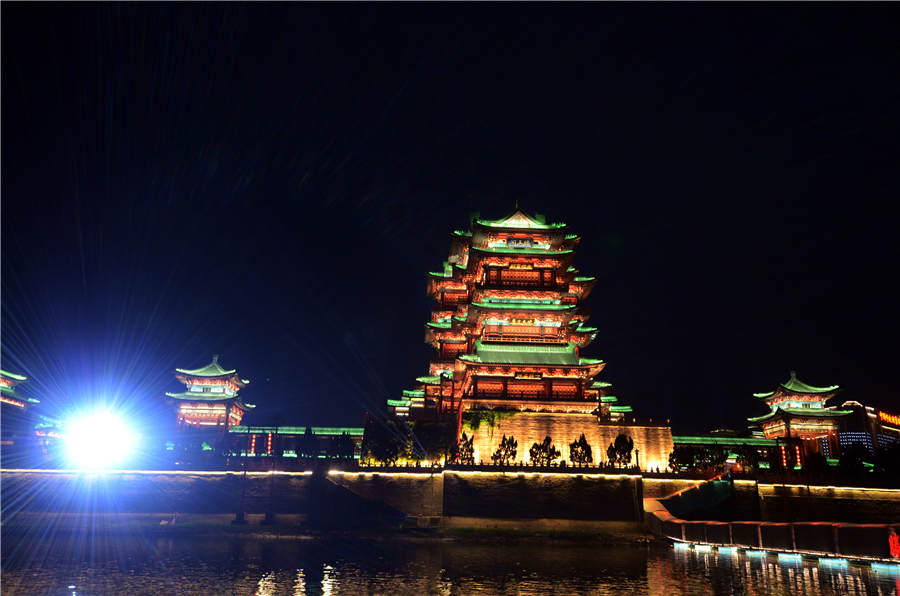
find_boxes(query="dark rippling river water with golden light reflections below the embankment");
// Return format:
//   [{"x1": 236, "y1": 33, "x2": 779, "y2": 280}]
[{"x1": 0, "y1": 537, "x2": 900, "y2": 596}]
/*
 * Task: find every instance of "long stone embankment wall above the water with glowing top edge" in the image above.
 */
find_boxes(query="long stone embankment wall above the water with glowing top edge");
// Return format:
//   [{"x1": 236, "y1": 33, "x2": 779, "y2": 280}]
[{"x1": 7, "y1": 468, "x2": 900, "y2": 552}]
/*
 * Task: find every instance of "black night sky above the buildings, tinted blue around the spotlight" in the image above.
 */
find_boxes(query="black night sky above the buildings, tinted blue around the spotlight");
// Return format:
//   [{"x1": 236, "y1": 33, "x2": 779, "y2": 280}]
[{"x1": 2, "y1": 3, "x2": 900, "y2": 432}]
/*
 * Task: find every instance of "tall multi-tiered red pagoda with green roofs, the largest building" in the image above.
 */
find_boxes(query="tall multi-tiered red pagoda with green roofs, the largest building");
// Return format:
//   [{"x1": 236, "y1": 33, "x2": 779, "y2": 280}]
[{"x1": 388, "y1": 209, "x2": 671, "y2": 470}]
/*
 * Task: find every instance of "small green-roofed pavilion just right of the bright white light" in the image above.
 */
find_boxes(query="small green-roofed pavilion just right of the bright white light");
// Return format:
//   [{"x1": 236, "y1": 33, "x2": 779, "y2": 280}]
[{"x1": 166, "y1": 355, "x2": 255, "y2": 432}]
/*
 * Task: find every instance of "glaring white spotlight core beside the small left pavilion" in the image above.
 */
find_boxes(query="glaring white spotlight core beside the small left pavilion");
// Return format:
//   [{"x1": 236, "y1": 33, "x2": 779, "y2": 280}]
[{"x1": 65, "y1": 410, "x2": 137, "y2": 470}]
